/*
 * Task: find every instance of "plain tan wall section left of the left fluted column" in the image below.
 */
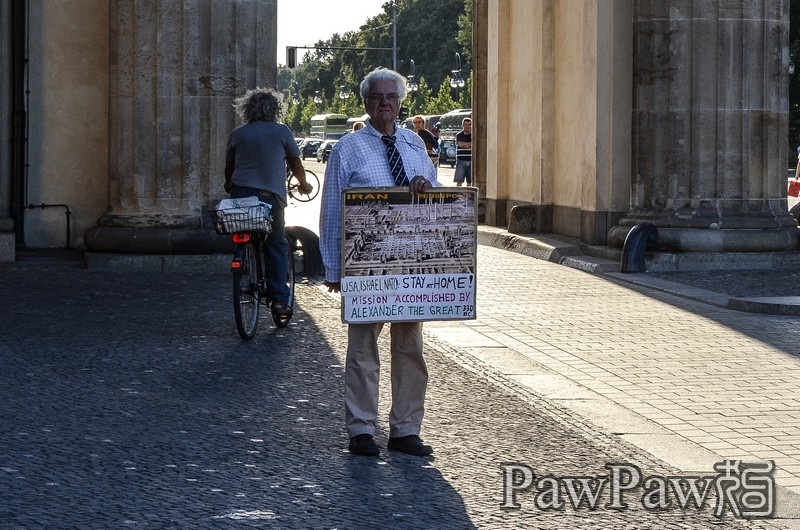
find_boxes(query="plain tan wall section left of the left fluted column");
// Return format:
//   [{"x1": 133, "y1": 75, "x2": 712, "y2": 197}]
[{"x1": 24, "y1": 0, "x2": 109, "y2": 248}]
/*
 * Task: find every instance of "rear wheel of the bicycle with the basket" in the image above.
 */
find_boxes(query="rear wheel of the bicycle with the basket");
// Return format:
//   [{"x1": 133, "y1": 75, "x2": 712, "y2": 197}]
[{"x1": 233, "y1": 241, "x2": 261, "y2": 340}]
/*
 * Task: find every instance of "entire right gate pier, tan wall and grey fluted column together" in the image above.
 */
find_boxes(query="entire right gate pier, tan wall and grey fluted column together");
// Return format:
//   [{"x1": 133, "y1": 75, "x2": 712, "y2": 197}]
[{"x1": 473, "y1": 0, "x2": 798, "y2": 252}]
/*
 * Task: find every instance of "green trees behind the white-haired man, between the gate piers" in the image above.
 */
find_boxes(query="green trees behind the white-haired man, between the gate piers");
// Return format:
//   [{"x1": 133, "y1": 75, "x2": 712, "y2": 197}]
[{"x1": 277, "y1": 0, "x2": 472, "y2": 133}]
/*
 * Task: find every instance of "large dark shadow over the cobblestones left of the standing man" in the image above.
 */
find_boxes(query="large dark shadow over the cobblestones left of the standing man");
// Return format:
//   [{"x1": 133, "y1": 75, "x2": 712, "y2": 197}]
[{"x1": 0, "y1": 265, "x2": 473, "y2": 528}]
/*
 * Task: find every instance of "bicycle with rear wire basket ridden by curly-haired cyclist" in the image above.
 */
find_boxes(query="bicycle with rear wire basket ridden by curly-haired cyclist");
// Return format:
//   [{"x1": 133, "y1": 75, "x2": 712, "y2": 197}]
[{"x1": 210, "y1": 197, "x2": 295, "y2": 340}]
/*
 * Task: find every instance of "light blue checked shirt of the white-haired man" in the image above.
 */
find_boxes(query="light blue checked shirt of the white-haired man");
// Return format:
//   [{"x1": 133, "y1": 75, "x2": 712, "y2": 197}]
[{"x1": 319, "y1": 120, "x2": 441, "y2": 282}]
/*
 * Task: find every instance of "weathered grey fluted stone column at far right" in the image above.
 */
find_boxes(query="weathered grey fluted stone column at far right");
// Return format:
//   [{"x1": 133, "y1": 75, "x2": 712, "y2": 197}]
[{"x1": 609, "y1": 0, "x2": 797, "y2": 252}]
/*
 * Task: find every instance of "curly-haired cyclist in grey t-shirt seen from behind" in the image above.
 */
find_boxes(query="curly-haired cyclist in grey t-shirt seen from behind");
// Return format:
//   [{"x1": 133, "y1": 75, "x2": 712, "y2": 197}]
[{"x1": 225, "y1": 88, "x2": 313, "y2": 318}]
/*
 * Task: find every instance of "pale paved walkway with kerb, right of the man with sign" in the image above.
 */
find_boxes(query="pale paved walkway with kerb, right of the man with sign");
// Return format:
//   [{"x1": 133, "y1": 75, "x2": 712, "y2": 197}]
[{"x1": 440, "y1": 229, "x2": 800, "y2": 510}]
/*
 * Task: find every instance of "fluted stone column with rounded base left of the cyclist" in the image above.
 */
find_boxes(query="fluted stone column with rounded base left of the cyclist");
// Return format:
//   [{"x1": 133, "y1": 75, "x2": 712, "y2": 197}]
[{"x1": 85, "y1": 0, "x2": 277, "y2": 253}]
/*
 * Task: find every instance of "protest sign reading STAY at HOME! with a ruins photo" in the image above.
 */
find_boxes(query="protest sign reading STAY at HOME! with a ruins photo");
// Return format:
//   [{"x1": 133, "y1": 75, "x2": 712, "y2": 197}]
[{"x1": 341, "y1": 187, "x2": 477, "y2": 324}]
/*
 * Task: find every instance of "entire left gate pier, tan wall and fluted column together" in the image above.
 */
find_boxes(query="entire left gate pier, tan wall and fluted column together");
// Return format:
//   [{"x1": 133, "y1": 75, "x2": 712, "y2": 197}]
[{"x1": 0, "y1": 0, "x2": 277, "y2": 252}]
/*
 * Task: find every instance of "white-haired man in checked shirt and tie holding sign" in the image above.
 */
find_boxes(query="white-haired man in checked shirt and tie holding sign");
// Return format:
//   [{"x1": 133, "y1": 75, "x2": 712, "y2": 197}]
[{"x1": 320, "y1": 68, "x2": 440, "y2": 456}]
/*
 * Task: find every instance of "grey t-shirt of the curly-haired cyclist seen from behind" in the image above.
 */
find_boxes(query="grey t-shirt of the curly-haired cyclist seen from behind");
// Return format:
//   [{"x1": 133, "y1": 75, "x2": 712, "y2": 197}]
[{"x1": 225, "y1": 121, "x2": 300, "y2": 204}]
